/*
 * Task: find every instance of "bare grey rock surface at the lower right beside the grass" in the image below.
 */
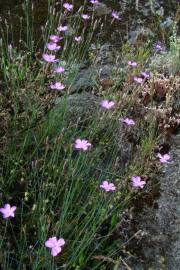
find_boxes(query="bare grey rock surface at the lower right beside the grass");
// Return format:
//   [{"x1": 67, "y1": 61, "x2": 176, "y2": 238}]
[{"x1": 132, "y1": 134, "x2": 180, "y2": 270}]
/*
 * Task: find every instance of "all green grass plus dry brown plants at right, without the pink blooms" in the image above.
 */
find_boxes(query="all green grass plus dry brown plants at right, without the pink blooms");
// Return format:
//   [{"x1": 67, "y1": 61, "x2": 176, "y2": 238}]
[{"x1": 0, "y1": 0, "x2": 180, "y2": 270}]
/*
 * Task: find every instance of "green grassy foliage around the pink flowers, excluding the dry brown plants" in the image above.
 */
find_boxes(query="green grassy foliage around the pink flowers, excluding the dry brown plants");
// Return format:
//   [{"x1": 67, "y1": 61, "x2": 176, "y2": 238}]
[{"x1": 0, "y1": 1, "x2": 177, "y2": 270}]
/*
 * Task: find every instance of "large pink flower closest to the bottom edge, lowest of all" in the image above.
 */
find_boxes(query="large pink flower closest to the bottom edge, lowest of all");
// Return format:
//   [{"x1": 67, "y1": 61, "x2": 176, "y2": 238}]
[{"x1": 45, "y1": 237, "x2": 65, "y2": 257}]
